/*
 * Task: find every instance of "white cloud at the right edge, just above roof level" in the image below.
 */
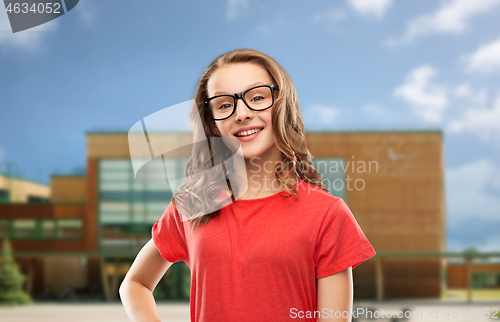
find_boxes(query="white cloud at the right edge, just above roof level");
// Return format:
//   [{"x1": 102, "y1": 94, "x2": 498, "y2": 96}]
[{"x1": 448, "y1": 96, "x2": 500, "y2": 144}]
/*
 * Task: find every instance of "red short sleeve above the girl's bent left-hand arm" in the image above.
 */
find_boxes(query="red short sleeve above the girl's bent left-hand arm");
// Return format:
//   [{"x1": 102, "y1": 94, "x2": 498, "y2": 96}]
[{"x1": 151, "y1": 201, "x2": 188, "y2": 263}]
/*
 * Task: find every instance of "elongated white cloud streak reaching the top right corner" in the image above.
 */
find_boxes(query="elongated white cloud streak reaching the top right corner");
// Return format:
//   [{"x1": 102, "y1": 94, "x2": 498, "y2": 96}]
[{"x1": 389, "y1": 0, "x2": 500, "y2": 44}]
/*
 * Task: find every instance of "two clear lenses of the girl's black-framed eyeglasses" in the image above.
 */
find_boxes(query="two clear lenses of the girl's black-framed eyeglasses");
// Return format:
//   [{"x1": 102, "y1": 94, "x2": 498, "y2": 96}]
[{"x1": 208, "y1": 86, "x2": 273, "y2": 119}]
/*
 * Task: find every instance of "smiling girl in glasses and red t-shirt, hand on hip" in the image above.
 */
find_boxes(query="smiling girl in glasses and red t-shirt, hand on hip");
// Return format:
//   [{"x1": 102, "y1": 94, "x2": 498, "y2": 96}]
[{"x1": 120, "y1": 49, "x2": 376, "y2": 322}]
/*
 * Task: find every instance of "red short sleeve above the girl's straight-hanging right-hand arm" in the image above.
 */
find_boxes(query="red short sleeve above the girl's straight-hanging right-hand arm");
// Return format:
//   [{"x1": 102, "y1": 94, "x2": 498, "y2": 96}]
[{"x1": 314, "y1": 198, "x2": 376, "y2": 278}]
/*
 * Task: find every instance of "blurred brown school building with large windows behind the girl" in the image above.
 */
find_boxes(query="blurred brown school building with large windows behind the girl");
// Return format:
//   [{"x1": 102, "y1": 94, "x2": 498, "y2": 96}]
[{"x1": 0, "y1": 130, "x2": 468, "y2": 299}]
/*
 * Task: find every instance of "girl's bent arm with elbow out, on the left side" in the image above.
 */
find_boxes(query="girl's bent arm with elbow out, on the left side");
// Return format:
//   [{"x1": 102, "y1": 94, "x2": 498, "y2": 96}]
[{"x1": 119, "y1": 239, "x2": 172, "y2": 322}]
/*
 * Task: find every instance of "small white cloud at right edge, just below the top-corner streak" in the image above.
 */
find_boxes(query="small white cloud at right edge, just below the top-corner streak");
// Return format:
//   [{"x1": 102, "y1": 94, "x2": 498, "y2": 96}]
[{"x1": 465, "y1": 38, "x2": 500, "y2": 74}]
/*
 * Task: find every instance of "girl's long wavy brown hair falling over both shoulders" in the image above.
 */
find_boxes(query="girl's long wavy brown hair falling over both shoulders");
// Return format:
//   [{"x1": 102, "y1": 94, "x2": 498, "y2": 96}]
[{"x1": 172, "y1": 49, "x2": 330, "y2": 230}]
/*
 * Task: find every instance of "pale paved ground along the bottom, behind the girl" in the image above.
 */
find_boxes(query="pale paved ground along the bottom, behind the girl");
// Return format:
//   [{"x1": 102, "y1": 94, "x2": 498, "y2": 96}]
[{"x1": 0, "y1": 300, "x2": 500, "y2": 322}]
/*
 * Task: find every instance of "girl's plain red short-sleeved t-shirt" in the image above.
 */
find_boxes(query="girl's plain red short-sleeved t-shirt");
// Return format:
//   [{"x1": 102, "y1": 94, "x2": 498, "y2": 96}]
[{"x1": 152, "y1": 179, "x2": 376, "y2": 322}]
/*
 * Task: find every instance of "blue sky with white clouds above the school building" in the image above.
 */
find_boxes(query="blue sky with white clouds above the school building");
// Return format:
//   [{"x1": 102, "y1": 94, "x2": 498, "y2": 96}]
[{"x1": 0, "y1": 0, "x2": 500, "y2": 251}]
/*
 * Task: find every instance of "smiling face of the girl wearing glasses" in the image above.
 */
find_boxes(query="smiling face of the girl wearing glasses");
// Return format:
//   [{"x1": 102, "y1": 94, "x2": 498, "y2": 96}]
[{"x1": 207, "y1": 63, "x2": 278, "y2": 159}]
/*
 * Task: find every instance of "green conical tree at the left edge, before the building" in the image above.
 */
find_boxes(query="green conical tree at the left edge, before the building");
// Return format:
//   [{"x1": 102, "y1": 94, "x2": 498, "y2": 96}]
[{"x1": 0, "y1": 238, "x2": 33, "y2": 305}]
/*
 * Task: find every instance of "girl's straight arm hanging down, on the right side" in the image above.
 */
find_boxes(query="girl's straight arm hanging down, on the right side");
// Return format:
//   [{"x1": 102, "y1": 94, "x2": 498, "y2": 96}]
[{"x1": 316, "y1": 267, "x2": 353, "y2": 322}]
